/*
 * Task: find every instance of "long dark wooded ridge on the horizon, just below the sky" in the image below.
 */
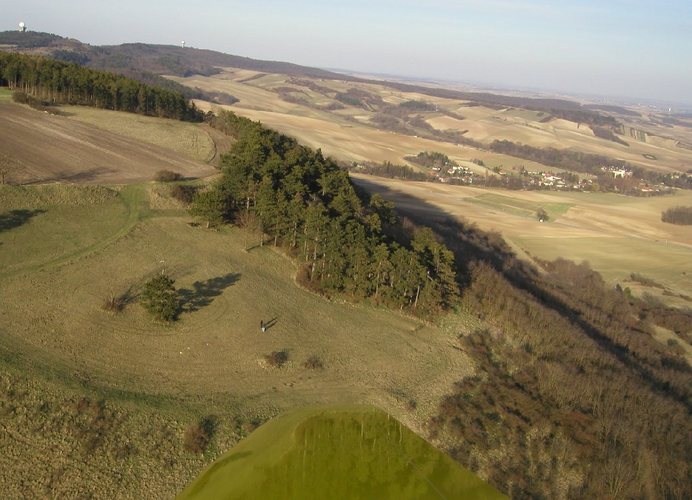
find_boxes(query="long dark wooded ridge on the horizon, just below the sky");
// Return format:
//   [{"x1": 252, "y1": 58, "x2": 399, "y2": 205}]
[{"x1": 0, "y1": 31, "x2": 618, "y2": 127}]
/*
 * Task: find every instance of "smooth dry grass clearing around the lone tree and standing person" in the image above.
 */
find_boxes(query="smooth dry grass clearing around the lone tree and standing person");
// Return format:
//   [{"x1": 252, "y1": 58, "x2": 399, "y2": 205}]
[{"x1": 0, "y1": 179, "x2": 474, "y2": 418}]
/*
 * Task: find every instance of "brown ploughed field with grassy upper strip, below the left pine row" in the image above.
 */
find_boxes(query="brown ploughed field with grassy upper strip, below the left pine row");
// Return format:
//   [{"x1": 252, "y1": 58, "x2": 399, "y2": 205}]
[{"x1": 0, "y1": 100, "x2": 216, "y2": 183}]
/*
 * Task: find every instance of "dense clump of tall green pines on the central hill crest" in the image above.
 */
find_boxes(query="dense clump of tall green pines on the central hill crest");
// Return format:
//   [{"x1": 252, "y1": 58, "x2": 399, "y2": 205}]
[{"x1": 193, "y1": 112, "x2": 459, "y2": 317}]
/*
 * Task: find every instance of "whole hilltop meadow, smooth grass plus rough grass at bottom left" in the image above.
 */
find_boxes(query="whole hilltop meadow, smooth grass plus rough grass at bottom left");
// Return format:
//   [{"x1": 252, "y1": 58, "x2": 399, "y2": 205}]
[{"x1": 0, "y1": 184, "x2": 473, "y2": 497}]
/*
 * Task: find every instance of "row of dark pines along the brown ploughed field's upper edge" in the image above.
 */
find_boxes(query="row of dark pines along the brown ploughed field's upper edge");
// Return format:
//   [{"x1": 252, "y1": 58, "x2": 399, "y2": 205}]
[{"x1": 0, "y1": 52, "x2": 203, "y2": 121}]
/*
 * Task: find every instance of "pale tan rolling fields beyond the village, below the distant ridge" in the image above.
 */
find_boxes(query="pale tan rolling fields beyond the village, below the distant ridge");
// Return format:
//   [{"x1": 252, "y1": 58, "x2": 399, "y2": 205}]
[{"x1": 174, "y1": 70, "x2": 692, "y2": 176}]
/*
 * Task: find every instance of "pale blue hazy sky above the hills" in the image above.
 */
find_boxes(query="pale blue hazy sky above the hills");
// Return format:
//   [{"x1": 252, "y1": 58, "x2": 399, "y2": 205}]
[{"x1": 5, "y1": 0, "x2": 692, "y2": 105}]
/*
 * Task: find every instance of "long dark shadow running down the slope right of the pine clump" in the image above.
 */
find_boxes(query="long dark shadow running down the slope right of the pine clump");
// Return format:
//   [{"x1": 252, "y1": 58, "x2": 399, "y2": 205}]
[{"x1": 351, "y1": 178, "x2": 692, "y2": 412}]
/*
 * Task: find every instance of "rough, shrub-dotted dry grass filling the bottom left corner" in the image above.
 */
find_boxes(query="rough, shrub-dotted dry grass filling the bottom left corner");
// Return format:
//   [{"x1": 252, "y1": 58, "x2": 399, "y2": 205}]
[{"x1": 0, "y1": 366, "x2": 240, "y2": 498}]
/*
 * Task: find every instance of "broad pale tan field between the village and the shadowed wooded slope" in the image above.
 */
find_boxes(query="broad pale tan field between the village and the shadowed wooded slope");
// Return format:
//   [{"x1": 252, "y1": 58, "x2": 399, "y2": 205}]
[{"x1": 351, "y1": 174, "x2": 692, "y2": 308}]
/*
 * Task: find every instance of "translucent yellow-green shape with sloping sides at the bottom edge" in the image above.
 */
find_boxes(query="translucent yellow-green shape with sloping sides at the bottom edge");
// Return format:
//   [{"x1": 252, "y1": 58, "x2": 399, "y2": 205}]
[{"x1": 179, "y1": 406, "x2": 505, "y2": 500}]
